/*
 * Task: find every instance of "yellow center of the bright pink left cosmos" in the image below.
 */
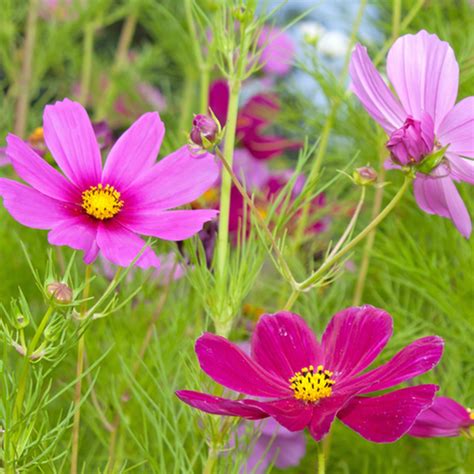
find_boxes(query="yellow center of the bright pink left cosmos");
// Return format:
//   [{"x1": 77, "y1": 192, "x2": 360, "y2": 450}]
[{"x1": 82, "y1": 184, "x2": 123, "y2": 221}]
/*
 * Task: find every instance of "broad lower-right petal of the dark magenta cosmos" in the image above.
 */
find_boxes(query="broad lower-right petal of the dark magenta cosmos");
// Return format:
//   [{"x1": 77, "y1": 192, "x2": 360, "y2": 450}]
[{"x1": 338, "y1": 385, "x2": 438, "y2": 443}]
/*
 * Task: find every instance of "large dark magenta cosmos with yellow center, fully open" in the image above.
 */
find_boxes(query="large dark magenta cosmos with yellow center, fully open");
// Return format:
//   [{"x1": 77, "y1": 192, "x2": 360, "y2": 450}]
[{"x1": 177, "y1": 306, "x2": 443, "y2": 443}]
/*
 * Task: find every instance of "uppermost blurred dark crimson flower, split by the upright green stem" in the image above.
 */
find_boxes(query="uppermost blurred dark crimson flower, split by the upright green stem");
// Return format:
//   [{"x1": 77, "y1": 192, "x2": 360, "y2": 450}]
[{"x1": 209, "y1": 80, "x2": 302, "y2": 160}]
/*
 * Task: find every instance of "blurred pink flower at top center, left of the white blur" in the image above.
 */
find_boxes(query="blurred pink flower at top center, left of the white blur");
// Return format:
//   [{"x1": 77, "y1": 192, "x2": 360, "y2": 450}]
[{"x1": 257, "y1": 26, "x2": 295, "y2": 76}]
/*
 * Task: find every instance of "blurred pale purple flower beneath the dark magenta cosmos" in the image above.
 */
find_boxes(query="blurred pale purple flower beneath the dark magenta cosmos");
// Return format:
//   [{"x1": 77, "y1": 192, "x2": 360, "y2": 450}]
[{"x1": 231, "y1": 418, "x2": 306, "y2": 474}]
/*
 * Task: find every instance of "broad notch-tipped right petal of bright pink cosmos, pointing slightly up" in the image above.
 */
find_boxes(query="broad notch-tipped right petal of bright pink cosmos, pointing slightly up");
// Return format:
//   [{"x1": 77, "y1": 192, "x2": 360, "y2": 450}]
[{"x1": 124, "y1": 145, "x2": 219, "y2": 209}]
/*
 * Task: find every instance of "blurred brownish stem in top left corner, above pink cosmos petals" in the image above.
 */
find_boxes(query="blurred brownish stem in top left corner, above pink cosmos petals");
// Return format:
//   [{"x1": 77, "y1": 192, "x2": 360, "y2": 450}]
[{"x1": 14, "y1": 0, "x2": 39, "y2": 137}]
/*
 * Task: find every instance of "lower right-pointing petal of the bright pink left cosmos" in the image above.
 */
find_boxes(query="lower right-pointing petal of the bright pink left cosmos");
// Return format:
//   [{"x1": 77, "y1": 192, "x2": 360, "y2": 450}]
[{"x1": 120, "y1": 209, "x2": 218, "y2": 240}]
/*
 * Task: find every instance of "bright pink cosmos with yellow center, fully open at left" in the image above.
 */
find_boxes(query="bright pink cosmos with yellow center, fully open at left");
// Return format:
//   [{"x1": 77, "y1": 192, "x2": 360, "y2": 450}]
[{"x1": 0, "y1": 99, "x2": 218, "y2": 268}]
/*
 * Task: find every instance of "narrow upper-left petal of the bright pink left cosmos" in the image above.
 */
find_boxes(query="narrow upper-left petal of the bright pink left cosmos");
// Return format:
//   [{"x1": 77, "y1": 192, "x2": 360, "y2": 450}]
[{"x1": 7, "y1": 134, "x2": 80, "y2": 202}]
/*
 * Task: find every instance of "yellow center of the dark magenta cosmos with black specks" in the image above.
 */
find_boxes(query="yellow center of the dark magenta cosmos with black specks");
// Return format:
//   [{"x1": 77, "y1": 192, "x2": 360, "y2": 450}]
[{"x1": 290, "y1": 365, "x2": 336, "y2": 402}]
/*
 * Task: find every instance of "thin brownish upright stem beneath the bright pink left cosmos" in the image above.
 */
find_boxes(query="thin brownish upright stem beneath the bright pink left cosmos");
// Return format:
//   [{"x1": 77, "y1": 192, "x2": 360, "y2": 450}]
[{"x1": 71, "y1": 265, "x2": 92, "y2": 474}]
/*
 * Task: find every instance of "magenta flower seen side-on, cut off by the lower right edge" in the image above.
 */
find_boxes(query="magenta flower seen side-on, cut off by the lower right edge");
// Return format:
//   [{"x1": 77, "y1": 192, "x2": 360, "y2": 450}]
[{"x1": 408, "y1": 397, "x2": 474, "y2": 438}]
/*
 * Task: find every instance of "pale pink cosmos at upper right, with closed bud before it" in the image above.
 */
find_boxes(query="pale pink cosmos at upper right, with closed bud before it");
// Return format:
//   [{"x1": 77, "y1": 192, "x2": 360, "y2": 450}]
[{"x1": 350, "y1": 31, "x2": 474, "y2": 237}]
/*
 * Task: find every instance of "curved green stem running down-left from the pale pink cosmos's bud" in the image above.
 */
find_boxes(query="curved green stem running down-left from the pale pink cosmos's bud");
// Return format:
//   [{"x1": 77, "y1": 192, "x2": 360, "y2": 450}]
[{"x1": 299, "y1": 176, "x2": 413, "y2": 291}]
